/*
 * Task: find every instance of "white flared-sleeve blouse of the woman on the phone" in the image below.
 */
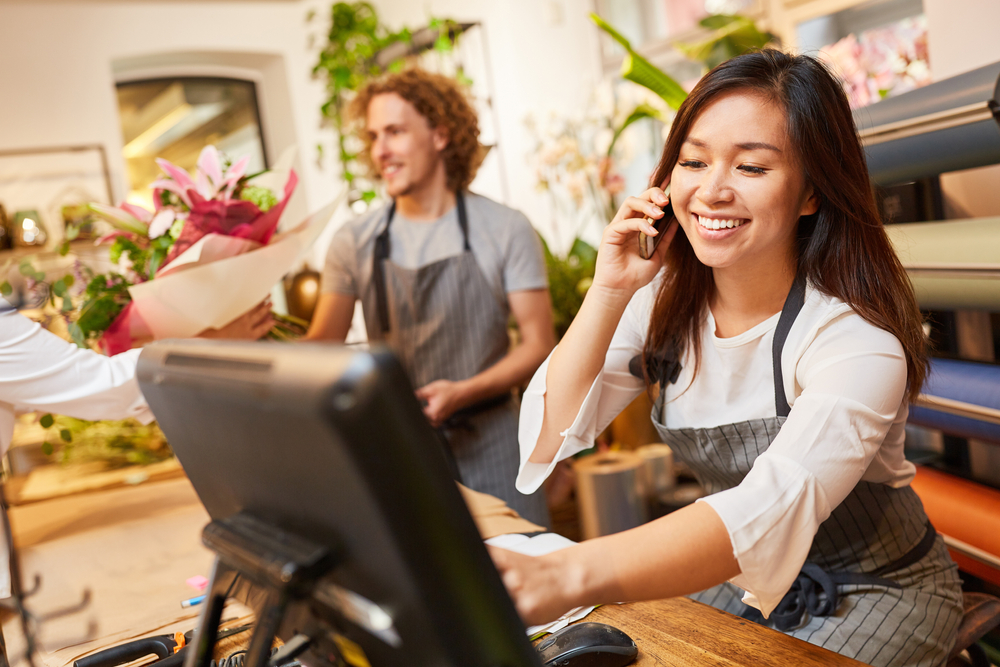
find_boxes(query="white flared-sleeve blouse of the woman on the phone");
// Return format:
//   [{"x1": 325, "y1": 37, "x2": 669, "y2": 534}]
[{"x1": 517, "y1": 285, "x2": 915, "y2": 616}]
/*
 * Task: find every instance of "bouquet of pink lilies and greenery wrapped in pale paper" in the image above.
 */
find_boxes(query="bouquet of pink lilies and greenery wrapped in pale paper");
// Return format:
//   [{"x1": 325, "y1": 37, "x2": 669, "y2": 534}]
[{"x1": 51, "y1": 146, "x2": 336, "y2": 355}]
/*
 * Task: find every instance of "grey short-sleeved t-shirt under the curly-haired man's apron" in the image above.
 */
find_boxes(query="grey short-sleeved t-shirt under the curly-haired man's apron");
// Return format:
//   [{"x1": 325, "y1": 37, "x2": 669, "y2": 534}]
[{"x1": 321, "y1": 192, "x2": 548, "y2": 310}]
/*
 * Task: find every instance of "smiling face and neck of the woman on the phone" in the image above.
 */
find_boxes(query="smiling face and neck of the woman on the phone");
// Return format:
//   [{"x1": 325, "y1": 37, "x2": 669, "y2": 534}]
[{"x1": 670, "y1": 90, "x2": 817, "y2": 302}]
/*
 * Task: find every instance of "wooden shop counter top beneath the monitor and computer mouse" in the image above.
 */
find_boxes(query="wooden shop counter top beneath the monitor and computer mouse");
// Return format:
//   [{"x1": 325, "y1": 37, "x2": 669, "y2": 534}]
[{"x1": 3, "y1": 478, "x2": 861, "y2": 667}]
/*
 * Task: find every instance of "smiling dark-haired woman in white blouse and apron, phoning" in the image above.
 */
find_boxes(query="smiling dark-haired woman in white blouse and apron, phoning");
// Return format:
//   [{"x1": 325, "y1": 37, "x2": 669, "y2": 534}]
[{"x1": 494, "y1": 50, "x2": 962, "y2": 666}]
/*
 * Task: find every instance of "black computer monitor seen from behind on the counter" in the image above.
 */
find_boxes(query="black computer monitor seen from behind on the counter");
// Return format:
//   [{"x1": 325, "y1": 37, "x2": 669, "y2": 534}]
[{"x1": 138, "y1": 341, "x2": 539, "y2": 667}]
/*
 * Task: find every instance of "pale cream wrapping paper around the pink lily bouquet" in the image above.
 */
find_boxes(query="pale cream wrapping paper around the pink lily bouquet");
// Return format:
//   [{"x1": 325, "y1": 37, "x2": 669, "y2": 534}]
[{"x1": 129, "y1": 189, "x2": 347, "y2": 339}]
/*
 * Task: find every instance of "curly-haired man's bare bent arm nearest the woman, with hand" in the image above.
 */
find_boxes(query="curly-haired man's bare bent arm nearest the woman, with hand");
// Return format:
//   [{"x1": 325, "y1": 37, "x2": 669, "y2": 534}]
[{"x1": 417, "y1": 288, "x2": 555, "y2": 424}]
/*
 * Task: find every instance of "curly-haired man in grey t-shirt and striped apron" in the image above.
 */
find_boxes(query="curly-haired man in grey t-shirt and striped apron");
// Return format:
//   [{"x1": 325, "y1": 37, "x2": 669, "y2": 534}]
[{"x1": 307, "y1": 70, "x2": 555, "y2": 525}]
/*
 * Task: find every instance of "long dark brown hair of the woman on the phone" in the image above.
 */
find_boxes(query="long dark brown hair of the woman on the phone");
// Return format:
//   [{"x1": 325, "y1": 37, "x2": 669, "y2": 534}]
[{"x1": 643, "y1": 49, "x2": 927, "y2": 400}]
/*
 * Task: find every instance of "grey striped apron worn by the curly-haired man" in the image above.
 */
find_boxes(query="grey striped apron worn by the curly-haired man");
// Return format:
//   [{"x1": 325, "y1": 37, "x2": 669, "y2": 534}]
[{"x1": 362, "y1": 193, "x2": 549, "y2": 527}]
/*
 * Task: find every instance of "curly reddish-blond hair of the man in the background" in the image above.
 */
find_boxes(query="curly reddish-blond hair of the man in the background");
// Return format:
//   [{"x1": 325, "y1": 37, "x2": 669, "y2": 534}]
[{"x1": 347, "y1": 68, "x2": 483, "y2": 192}]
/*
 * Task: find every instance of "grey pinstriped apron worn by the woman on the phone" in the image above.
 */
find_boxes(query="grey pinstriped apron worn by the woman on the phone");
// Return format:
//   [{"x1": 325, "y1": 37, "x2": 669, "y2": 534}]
[{"x1": 652, "y1": 279, "x2": 962, "y2": 667}]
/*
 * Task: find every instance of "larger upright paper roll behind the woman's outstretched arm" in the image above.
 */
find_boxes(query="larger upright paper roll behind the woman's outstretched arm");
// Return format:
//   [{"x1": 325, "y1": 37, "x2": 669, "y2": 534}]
[{"x1": 573, "y1": 451, "x2": 649, "y2": 540}]
